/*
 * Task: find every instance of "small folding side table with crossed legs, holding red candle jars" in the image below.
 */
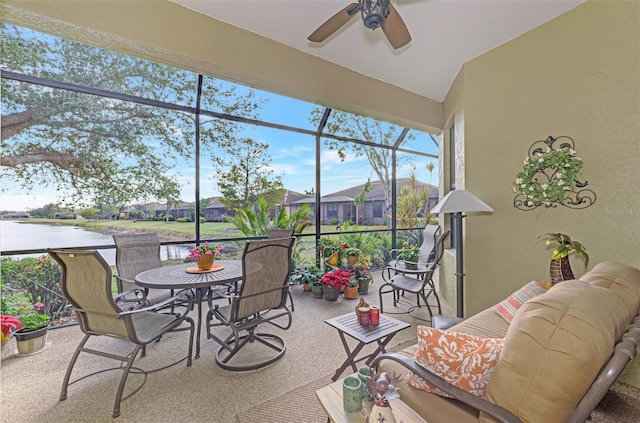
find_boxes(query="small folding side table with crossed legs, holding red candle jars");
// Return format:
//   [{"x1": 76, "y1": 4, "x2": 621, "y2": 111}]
[{"x1": 324, "y1": 312, "x2": 411, "y2": 381}]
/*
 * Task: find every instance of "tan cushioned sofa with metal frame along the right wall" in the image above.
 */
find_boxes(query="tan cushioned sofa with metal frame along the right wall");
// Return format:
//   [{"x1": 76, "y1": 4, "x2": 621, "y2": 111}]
[{"x1": 372, "y1": 261, "x2": 640, "y2": 423}]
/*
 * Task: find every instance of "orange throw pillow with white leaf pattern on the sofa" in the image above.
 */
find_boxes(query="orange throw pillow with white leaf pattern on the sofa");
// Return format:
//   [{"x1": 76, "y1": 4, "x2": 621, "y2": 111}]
[{"x1": 406, "y1": 326, "x2": 503, "y2": 398}]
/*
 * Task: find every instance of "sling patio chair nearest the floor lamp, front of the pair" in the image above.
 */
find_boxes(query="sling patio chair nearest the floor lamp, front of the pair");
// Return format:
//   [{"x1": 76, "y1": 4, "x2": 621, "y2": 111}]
[{"x1": 378, "y1": 231, "x2": 451, "y2": 319}]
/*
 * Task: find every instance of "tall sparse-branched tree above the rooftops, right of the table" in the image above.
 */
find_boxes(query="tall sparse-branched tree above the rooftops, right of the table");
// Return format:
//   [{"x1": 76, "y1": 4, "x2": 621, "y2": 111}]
[{"x1": 309, "y1": 108, "x2": 434, "y2": 220}]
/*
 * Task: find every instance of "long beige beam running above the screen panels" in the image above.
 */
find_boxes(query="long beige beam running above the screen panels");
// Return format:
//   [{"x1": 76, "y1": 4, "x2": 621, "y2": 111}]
[{"x1": 0, "y1": 0, "x2": 442, "y2": 132}]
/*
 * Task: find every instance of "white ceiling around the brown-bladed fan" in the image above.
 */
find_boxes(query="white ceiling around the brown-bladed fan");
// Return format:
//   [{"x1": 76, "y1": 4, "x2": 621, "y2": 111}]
[{"x1": 171, "y1": 0, "x2": 585, "y2": 101}]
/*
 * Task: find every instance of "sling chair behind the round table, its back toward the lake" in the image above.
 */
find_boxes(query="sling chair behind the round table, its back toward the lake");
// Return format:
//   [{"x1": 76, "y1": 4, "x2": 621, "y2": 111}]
[{"x1": 113, "y1": 232, "x2": 173, "y2": 311}]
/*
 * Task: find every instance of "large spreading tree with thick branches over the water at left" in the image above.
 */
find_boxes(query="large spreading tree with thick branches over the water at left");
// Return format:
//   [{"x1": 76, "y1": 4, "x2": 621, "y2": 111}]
[{"x1": 0, "y1": 24, "x2": 258, "y2": 209}]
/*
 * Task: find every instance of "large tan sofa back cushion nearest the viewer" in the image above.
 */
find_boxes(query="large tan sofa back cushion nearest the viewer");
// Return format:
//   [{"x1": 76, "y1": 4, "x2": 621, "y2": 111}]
[{"x1": 480, "y1": 281, "x2": 629, "y2": 423}]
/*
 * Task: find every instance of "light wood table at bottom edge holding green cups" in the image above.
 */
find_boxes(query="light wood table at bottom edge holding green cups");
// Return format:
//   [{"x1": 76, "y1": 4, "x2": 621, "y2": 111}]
[{"x1": 316, "y1": 379, "x2": 427, "y2": 423}]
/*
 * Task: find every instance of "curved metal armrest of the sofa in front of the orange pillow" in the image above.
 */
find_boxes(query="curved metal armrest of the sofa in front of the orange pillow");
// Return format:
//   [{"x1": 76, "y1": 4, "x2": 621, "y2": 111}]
[{"x1": 371, "y1": 353, "x2": 523, "y2": 423}]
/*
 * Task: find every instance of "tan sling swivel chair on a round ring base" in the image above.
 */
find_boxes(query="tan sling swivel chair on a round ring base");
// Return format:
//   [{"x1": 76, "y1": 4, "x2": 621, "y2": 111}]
[{"x1": 207, "y1": 237, "x2": 294, "y2": 371}]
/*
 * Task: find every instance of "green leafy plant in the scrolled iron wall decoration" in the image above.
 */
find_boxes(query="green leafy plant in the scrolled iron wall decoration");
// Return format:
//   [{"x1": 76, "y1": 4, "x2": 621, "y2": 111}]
[{"x1": 514, "y1": 147, "x2": 583, "y2": 207}]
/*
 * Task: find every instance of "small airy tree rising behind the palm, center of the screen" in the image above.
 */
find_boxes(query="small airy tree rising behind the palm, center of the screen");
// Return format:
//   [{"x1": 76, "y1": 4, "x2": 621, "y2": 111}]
[{"x1": 218, "y1": 138, "x2": 284, "y2": 209}]
